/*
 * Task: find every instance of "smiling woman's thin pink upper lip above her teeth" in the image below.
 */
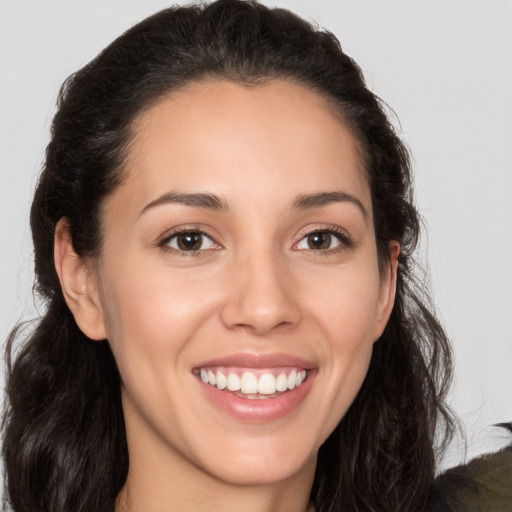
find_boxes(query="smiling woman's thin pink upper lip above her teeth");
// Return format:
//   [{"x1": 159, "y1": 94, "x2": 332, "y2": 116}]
[{"x1": 195, "y1": 353, "x2": 315, "y2": 370}]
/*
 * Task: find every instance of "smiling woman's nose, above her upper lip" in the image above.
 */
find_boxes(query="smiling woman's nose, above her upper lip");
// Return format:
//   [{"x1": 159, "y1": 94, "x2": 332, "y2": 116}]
[{"x1": 221, "y1": 255, "x2": 302, "y2": 336}]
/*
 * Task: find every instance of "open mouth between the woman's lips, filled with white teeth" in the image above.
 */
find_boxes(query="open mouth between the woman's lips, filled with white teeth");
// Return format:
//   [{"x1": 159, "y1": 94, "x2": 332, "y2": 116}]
[{"x1": 194, "y1": 367, "x2": 308, "y2": 400}]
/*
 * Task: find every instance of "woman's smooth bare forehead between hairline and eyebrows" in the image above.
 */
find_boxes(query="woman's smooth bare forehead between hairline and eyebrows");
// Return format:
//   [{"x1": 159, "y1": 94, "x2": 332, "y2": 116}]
[{"x1": 112, "y1": 80, "x2": 371, "y2": 216}]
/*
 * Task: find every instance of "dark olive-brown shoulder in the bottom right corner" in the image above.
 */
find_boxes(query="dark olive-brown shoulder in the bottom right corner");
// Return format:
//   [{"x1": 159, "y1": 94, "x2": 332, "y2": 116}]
[{"x1": 427, "y1": 423, "x2": 512, "y2": 512}]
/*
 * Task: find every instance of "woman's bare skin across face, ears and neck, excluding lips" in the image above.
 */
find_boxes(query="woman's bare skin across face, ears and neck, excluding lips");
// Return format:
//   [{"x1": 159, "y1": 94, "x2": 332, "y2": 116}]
[{"x1": 55, "y1": 81, "x2": 399, "y2": 512}]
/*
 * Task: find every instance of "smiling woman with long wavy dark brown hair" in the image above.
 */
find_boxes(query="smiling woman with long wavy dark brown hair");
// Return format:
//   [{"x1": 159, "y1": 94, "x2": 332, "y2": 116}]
[{"x1": 4, "y1": 1, "x2": 510, "y2": 511}]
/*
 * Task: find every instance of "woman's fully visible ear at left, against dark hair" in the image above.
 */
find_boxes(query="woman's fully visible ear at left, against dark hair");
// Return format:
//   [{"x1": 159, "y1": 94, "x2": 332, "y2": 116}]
[{"x1": 54, "y1": 218, "x2": 107, "y2": 340}]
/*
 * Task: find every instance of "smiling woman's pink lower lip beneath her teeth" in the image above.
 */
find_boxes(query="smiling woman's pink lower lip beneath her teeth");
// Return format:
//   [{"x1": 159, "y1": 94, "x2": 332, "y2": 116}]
[{"x1": 198, "y1": 370, "x2": 315, "y2": 422}]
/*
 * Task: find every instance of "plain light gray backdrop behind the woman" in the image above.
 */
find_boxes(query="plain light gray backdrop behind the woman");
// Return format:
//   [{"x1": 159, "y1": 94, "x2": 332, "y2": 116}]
[{"x1": 0, "y1": 0, "x2": 512, "y2": 472}]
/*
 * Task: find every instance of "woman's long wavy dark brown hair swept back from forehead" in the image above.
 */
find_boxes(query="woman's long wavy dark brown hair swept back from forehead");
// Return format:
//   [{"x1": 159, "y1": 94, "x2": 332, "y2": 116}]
[{"x1": 3, "y1": 0, "x2": 454, "y2": 512}]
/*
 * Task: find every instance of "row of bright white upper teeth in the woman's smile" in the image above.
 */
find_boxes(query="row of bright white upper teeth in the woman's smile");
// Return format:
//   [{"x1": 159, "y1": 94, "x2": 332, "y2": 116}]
[{"x1": 199, "y1": 368, "x2": 307, "y2": 398}]
